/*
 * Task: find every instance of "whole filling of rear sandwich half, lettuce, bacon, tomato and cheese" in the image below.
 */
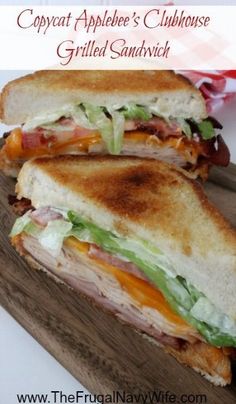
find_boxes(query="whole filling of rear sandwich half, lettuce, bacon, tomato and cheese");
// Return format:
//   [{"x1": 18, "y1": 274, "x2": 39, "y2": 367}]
[{"x1": 2, "y1": 103, "x2": 229, "y2": 175}]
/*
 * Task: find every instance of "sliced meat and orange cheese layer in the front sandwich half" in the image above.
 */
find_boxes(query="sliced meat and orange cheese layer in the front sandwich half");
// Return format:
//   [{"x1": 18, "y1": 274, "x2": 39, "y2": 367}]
[{"x1": 12, "y1": 233, "x2": 232, "y2": 386}]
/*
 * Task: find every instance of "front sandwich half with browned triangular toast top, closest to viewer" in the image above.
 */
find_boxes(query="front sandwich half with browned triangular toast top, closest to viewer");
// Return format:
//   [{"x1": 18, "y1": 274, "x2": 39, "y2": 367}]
[{"x1": 10, "y1": 156, "x2": 236, "y2": 386}]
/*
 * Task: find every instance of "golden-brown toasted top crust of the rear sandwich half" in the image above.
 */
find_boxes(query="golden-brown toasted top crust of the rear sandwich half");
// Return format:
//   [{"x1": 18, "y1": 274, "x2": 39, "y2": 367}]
[{"x1": 0, "y1": 70, "x2": 195, "y2": 104}]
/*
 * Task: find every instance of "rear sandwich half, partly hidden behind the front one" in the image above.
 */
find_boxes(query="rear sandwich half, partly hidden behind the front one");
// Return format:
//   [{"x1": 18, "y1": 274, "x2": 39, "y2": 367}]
[{"x1": 0, "y1": 70, "x2": 229, "y2": 178}]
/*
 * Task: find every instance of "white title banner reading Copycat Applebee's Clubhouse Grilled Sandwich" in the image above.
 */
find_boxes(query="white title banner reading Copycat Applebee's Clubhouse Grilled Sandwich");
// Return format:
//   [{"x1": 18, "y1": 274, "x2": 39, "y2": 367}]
[{"x1": 0, "y1": 6, "x2": 236, "y2": 70}]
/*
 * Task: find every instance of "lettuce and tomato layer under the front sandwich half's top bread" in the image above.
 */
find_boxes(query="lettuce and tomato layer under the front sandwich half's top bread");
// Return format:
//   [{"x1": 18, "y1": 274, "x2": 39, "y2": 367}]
[{"x1": 11, "y1": 207, "x2": 236, "y2": 347}]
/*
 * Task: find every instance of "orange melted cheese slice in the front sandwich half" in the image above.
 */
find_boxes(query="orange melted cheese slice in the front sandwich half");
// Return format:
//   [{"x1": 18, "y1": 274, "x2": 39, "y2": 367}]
[{"x1": 65, "y1": 237, "x2": 192, "y2": 332}]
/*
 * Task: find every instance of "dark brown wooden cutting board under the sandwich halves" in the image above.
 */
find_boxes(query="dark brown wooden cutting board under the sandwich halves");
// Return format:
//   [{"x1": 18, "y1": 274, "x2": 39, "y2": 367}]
[{"x1": 0, "y1": 165, "x2": 236, "y2": 404}]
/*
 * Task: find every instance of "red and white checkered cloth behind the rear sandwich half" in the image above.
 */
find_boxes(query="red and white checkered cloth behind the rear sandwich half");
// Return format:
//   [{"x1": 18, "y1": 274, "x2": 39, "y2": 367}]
[{"x1": 179, "y1": 70, "x2": 236, "y2": 113}]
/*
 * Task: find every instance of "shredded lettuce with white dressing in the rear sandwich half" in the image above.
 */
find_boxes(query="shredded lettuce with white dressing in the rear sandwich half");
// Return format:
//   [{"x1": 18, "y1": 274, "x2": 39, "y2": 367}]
[{"x1": 23, "y1": 103, "x2": 215, "y2": 155}]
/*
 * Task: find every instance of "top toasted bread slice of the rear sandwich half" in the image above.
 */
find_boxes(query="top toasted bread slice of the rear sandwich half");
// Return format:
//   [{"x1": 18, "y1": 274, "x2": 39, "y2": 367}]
[{"x1": 0, "y1": 70, "x2": 206, "y2": 125}]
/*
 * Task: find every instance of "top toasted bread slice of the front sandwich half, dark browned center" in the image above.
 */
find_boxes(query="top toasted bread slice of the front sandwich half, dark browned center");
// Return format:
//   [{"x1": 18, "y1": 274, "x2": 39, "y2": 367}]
[{"x1": 16, "y1": 156, "x2": 236, "y2": 319}]
